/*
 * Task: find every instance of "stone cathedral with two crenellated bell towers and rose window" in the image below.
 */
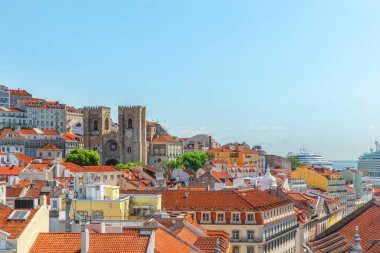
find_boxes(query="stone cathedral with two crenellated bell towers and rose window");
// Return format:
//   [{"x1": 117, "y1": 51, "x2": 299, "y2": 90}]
[{"x1": 83, "y1": 106, "x2": 148, "y2": 165}]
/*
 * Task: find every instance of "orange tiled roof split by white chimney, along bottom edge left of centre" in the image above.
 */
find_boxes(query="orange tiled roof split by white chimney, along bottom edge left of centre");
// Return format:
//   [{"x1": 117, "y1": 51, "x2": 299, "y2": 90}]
[{"x1": 29, "y1": 230, "x2": 150, "y2": 253}]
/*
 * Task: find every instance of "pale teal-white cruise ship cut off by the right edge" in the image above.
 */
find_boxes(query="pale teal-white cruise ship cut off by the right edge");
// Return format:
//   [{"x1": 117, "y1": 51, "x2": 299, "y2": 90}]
[{"x1": 358, "y1": 141, "x2": 380, "y2": 185}]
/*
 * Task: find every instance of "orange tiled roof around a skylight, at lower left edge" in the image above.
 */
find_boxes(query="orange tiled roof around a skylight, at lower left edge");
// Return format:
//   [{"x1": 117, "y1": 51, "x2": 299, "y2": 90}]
[{"x1": 0, "y1": 209, "x2": 38, "y2": 239}]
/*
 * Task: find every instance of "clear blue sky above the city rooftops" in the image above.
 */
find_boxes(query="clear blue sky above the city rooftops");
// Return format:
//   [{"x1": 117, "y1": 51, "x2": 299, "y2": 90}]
[{"x1": 0, "y1": 0, "x2": 380, "y2": 159}]
